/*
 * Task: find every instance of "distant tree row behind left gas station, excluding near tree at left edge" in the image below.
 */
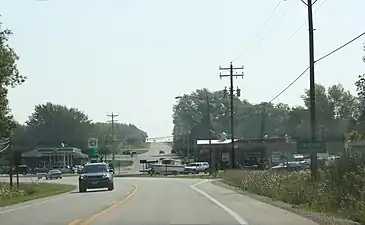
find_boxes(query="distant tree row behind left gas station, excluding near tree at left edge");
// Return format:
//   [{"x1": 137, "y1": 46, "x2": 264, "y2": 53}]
[{"x1": 13, "y1": 102, "x2": 147, "y2": 152}]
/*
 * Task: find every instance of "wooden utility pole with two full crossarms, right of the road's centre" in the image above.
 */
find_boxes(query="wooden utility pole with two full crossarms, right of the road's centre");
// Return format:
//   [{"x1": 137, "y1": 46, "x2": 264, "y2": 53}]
[{"x1": 219, "y1": 62, "x2": 244, "y2": 169}]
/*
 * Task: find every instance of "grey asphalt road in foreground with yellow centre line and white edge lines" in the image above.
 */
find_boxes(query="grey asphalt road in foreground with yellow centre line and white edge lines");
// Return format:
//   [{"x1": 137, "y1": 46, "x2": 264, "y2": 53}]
[{"x1": 0, "y1": 177, "x2": 315, "y2": 225}]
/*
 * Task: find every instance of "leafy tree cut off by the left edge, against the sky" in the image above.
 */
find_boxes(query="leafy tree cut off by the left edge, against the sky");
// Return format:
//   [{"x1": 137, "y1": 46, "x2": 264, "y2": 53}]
[{"x1": 0, "y1": 22, "x2": 26, "y2": 137}]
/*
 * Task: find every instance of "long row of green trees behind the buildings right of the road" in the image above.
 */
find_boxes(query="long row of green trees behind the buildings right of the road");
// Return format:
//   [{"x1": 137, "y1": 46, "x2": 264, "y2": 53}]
[{"x1": 173, "y1": 45, "x2": 365, "y2": 154}]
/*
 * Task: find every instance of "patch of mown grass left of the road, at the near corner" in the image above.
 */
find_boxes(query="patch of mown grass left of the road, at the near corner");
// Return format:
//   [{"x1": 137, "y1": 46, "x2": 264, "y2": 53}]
[{"x1": 0, "y1": 183, "x2": 76, "y2": 206}]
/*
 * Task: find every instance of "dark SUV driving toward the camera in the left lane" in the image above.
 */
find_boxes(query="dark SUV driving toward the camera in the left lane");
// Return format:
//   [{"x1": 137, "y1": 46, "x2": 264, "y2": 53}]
[{"x1": 79, "y1": 163, "x2": 114, "y2": 192}]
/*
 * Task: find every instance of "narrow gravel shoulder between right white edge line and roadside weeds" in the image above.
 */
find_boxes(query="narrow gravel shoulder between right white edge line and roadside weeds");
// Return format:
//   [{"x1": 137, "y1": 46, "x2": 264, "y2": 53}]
[{"x1": 211, "y1": 180, "x2": 358, "y2": 225}]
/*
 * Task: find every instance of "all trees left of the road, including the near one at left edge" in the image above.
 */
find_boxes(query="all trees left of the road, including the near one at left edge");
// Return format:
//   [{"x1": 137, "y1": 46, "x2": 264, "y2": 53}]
[{"x1": 0, "y1": 22, "x2": 147, "y2": 154}]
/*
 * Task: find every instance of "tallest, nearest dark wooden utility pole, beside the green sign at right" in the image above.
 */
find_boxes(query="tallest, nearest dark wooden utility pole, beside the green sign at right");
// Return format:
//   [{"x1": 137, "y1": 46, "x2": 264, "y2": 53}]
[{"x1": 301, "y1": 0, "x2": 317, "y2": 179}]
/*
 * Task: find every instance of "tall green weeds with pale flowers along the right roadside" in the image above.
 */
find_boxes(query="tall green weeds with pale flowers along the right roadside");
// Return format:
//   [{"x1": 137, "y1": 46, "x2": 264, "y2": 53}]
[{"x1": 224, "y1": 153, "x2": 365, "y2": 223}]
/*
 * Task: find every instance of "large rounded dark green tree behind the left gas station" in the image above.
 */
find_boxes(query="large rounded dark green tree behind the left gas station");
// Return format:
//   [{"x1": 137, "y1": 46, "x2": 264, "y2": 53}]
[{"x1": 26, "y1": 102, "x2": 93, "y2": 148}]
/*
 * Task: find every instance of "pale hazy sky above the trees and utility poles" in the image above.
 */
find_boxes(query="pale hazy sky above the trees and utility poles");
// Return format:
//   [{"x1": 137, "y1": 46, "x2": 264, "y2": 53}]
[{"x1": 0, "y1": 0, "x2": 365, "y2": 137}]
